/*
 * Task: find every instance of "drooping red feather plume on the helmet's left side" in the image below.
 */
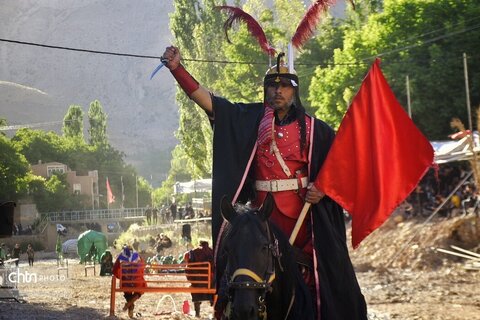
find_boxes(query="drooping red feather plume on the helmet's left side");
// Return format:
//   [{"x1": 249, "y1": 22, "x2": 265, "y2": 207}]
[{"x1": 215, "y1": 6, "x2": 275, "y2": 56}]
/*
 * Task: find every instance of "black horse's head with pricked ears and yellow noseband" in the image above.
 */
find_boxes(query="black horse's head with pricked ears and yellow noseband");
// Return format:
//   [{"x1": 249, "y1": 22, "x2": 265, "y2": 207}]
[{"x1": 221, "y1": 194, "x2": 279, "y2": 320}]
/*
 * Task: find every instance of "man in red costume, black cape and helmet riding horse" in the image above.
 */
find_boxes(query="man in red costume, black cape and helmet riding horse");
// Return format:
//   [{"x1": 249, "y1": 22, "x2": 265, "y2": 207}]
[{"x1": 162, "y1": 3, "x2": 367, "y2": 320}]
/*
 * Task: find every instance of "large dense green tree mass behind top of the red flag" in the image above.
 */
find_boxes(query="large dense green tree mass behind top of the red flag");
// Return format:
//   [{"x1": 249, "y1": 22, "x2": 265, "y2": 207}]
[{"x1": 309, "y1": 0, "x2": 480, "y2": 139}]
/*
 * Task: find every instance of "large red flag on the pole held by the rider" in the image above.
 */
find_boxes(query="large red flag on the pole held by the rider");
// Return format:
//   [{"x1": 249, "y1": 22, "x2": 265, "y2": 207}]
[{"x1": 315, "y1": 59, "x2": 433, "y2": 248}]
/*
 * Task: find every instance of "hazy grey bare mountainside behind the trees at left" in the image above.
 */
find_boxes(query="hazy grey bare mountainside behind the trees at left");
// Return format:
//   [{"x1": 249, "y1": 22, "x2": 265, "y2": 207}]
[{"x1": 0, "y1": 0, "x2": 178, "y2": 179}]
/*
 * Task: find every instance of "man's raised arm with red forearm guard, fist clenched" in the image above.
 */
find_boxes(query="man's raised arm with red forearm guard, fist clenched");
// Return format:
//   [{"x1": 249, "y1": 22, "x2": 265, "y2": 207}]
[{"x1": 162, "y1": 46, "x2": 213, "y2": 115}]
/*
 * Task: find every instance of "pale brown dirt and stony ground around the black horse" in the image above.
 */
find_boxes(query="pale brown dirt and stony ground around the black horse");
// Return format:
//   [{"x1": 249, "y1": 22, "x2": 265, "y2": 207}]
[{"x1": 0, "y1": 217, "x2": 480, "y2": 320}]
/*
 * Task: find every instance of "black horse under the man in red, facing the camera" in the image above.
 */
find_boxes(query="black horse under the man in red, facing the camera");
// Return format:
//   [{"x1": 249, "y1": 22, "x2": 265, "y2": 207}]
[{"x1": 217, "y1": 194, "x2": 315, "y2": 320}]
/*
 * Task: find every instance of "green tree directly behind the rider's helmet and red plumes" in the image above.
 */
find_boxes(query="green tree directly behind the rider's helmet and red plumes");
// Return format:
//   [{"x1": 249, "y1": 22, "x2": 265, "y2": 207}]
[{"x1": 214, "y1": 0, "x2": 336, "y2": 108}]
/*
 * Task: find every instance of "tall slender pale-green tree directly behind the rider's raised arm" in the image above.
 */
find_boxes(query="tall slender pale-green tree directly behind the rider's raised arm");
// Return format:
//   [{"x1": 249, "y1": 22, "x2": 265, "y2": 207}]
[{"x1": 170, "y1": 0, "x2": 224, "y2": 177}]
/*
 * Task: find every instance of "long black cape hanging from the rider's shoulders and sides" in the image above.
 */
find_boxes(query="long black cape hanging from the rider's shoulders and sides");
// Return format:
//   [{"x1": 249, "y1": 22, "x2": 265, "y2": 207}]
[{"x1": 212, "y1": 96, "x2": 367, "y2": 320}]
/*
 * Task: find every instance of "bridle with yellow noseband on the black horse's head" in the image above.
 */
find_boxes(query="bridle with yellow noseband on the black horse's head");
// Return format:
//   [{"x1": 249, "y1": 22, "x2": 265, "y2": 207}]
[{"x1": 227, "y1": 222, "x2": 283, "y2": 320}]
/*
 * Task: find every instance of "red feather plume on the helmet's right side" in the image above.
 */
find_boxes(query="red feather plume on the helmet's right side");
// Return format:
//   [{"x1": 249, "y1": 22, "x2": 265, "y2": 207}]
[{"x1": 292, "y1": 0, "x2": 335, "y2": 49}]
